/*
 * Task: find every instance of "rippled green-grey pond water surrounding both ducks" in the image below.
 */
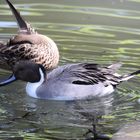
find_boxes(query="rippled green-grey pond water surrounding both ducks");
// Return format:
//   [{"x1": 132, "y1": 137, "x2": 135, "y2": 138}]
[{"x1": 0, "y1": 0, "x2": 140, "y2": 140}]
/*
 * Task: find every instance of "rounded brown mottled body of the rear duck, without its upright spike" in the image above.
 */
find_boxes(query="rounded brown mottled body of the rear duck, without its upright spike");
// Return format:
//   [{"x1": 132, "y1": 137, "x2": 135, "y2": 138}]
[{"x1": 0, "y1": 34, "x2": 59, "y2": 69}]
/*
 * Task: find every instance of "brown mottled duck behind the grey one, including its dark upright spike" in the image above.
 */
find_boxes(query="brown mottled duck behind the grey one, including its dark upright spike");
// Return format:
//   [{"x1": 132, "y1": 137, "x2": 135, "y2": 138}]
[{"x1": 0, "y1": 0, "x2": 59, "y2": 70}]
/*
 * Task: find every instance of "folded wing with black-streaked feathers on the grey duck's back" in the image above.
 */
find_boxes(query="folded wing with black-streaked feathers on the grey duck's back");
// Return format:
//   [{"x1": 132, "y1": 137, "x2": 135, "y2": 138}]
[{"x1": 52, "y1": 63, "x2": 120, "y2": 85}]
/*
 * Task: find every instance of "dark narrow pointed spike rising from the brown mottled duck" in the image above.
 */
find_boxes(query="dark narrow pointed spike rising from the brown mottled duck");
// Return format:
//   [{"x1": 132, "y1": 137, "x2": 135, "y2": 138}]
[{"x1": 6, "y1": 0, "x2": 28, "y2": 30}]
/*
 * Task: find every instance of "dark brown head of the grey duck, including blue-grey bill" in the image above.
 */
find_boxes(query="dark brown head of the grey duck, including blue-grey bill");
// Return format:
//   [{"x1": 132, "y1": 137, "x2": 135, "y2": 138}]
[{"x1": 0, "y1": 61, "x2": 46, "y2": 86}]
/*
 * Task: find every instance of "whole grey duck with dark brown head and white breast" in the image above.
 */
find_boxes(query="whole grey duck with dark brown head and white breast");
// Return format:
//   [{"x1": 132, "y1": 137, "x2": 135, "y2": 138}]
[{"x1": 0, "y1": 61, "x2": 140, "y2": 100}]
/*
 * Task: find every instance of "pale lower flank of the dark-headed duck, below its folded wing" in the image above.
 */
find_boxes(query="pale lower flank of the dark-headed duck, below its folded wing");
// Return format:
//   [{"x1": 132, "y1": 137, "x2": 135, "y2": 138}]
[{"x1": 30, "y1": 80, "x2": 114, "y2": 100}]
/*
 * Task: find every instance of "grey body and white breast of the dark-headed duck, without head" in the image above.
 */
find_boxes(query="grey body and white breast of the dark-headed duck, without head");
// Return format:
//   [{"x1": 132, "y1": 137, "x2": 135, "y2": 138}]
[{"x1": 23, "y1": 63, "x2": 138, "y2": 100}]
